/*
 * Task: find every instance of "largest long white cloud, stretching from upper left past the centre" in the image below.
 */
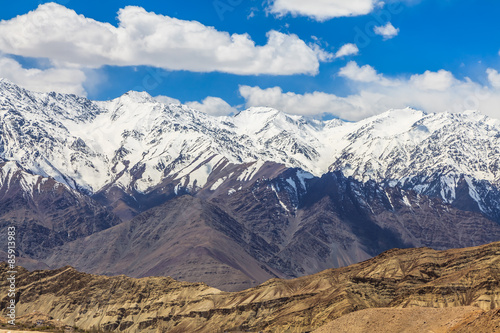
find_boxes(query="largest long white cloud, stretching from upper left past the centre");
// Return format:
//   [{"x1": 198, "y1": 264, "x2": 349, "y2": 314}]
[{"x1": 0, "y1": 3, "x2": 326, "y2": 75}]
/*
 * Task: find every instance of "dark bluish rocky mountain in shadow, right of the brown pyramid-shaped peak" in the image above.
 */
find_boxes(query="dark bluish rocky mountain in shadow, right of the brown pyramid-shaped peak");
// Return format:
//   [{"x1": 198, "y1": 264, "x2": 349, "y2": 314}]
[{"x1": 210, "y1": 169, "x2": 500, "y2": 277}]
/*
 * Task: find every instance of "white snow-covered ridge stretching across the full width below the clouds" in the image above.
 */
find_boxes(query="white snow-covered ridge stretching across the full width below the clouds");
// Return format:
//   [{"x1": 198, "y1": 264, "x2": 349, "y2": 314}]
[{"x1": 0, "y1": 80, "x2": 500, "y2": 202}]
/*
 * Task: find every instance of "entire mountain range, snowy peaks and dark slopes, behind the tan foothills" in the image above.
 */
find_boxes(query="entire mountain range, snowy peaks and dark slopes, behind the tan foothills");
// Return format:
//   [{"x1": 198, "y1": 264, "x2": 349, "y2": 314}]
[{"x1": 0, "y1": 79, "x2": 500, "y2": 290}]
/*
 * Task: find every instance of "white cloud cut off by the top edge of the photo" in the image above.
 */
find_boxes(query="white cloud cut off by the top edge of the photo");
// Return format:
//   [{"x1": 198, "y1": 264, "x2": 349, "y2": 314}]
[{"x1": 269, "y1": 0, "x2": 380, "y2": 21}]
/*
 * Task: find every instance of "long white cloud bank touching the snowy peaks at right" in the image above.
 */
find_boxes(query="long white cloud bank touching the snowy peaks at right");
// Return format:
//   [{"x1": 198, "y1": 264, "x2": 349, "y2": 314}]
[{"x1": 240, "y1": 62, "x2": 500, "y2": 120}]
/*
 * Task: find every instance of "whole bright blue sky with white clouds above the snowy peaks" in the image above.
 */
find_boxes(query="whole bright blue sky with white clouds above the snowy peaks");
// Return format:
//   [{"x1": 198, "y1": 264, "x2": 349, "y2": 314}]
[{"x1": 0, "y1": 0, "x2": 500, "y2": 120}]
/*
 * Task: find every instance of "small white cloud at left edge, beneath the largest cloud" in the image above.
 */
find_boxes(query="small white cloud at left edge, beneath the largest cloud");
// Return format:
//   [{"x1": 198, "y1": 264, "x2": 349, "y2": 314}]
[{"x1": 0, "y1": 56, "x2": 86, "y2": 96}]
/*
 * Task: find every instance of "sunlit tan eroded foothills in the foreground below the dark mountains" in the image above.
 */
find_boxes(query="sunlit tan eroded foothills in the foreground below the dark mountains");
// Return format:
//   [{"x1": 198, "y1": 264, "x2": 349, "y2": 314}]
[{"x1": 0, "y1": 243, "x2": 500, "y2": 332}]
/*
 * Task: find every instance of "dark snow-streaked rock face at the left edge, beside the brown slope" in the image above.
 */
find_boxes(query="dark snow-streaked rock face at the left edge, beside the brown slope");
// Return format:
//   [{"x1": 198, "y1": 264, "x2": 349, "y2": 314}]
[{"x1": 0, "y1": 162, "x2": 121, "y2": 260}]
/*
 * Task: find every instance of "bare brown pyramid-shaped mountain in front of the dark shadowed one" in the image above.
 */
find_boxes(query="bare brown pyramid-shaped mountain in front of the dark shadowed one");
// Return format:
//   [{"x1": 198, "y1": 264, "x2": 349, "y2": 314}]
[{"x1": 41, "y1": 195, "x2": 282, "y2": 290}]
